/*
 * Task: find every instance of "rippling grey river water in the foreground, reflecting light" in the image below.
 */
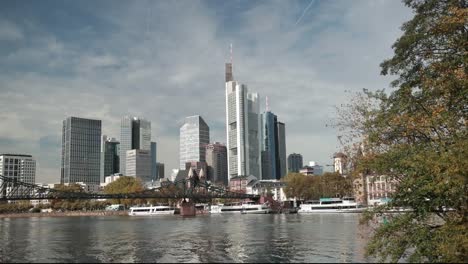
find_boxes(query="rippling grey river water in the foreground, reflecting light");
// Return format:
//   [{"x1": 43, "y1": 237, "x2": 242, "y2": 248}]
[{"x1": 0, "y1": 214, "x2": 372, "y2": 263}]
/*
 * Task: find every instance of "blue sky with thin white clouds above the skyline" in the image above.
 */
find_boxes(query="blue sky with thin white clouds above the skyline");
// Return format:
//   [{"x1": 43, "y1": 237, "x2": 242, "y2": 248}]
[{"x1": 0, "y1": 0, "x2": 412, "y2": 183}]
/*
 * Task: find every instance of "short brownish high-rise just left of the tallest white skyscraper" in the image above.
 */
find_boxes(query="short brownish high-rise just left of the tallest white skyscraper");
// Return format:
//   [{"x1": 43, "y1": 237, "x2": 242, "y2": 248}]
[{"x1": 206, "y1": 142, "x2": 228, "y2": 186}]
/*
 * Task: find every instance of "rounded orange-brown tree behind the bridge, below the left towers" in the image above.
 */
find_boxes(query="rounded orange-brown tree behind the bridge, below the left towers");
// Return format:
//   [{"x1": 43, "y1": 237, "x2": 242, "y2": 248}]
[{"x1": 104, "y1": 176, "x2": 146, "y2": 206}]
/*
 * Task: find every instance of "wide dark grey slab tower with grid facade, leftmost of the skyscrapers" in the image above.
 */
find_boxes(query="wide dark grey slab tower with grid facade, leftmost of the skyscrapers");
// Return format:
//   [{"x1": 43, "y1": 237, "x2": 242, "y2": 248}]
[{"x1": 60, "y1": 117, "x2": 101, "y2": 184}]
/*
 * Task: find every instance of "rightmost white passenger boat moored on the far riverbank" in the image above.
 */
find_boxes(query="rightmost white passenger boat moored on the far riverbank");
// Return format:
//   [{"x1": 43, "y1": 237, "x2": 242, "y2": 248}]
[{"x1": 297, "y1": 197, "x2": 366, "y2": 214}]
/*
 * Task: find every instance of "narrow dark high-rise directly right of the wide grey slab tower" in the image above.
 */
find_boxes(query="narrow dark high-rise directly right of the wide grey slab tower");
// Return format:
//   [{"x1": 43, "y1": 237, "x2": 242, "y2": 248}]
[{"x1": 101, "y1": 135, "x2": 120, "y2": 182}]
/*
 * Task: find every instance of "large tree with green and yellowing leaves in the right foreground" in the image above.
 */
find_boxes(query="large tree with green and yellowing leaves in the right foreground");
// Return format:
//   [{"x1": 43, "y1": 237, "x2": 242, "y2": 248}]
[{"x1": 338, "y1": 0, "x2": 468, "y2": 262}]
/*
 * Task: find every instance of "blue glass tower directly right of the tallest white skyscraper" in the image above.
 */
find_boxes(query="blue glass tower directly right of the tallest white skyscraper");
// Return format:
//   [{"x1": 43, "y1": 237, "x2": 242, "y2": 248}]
[{"x1": 262, "y1": 111, "x2": 287, "y2": 180}]
